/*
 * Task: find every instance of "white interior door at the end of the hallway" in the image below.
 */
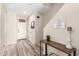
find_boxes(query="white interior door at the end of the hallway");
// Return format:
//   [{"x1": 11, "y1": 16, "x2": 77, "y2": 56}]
[{"x1": 18, "y1": 21, "x2": 26, "y2": 39}]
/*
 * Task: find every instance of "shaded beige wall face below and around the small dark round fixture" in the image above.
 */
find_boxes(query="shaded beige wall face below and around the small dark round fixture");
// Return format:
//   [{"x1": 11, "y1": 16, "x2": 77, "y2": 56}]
[{"x1": 35, "y1": 13, "x2": 43, "y2": 44}]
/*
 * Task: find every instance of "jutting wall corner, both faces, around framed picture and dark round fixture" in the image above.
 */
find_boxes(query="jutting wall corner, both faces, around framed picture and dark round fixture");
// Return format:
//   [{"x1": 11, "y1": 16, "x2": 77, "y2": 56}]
[{"x1": 28, "y1": 13, "x2": 43, "y2": 44}]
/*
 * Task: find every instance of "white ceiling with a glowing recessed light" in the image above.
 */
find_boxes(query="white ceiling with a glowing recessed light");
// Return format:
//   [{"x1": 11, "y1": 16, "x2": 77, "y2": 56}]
[{"x1": 6, "y1": 3, "x2": 52, "y2": 16}]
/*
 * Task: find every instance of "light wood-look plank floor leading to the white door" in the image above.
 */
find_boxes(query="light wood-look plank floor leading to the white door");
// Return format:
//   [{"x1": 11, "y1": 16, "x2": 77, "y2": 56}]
[{"x1": 2, "y1": 39, "x2": 40, "y2": 56}]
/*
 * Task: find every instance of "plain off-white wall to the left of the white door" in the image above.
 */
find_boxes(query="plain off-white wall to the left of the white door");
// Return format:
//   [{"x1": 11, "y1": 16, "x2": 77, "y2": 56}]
[{"x1": 1, "y1": 4, "x2": 17, "y2": 45}]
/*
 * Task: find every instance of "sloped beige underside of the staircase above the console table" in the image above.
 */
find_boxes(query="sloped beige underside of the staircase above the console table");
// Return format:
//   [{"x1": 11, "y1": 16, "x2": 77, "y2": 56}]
[{"x1": 43, "y1": 3, "x2": 64, "y2": 28}]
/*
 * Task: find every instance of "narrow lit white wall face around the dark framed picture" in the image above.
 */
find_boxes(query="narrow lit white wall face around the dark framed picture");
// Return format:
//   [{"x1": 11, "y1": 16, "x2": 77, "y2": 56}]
[{"x1": 28, "y1": 14, "x2": 35, "y2": 45}]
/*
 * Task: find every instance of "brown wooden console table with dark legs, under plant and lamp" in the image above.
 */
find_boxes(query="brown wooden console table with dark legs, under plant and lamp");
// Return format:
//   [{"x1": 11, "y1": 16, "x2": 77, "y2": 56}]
[{"x1": 40, "y1": 40, "x2": 76, "y2": 56}]
